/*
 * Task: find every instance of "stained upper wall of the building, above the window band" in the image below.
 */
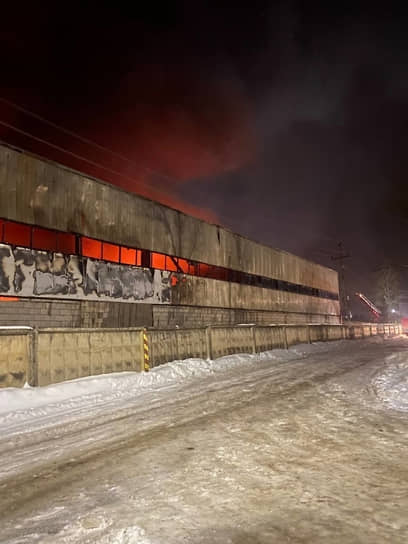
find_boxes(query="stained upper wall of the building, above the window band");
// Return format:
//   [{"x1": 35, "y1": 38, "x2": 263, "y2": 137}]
[{"x1": 0, "y1": 142, "x2": 338, "y2": 292}]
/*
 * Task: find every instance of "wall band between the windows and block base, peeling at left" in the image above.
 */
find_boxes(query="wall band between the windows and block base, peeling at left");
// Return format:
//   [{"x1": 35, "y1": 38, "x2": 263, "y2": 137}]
[{"x1": 0, "y1": 240, "x2": 339, "y2": 320}]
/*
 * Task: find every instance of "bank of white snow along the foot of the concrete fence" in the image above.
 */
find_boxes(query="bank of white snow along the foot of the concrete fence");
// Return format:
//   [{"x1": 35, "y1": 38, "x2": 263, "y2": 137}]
[{"x1": 0, "y1": 340, "x2": 349, "y2": 434}]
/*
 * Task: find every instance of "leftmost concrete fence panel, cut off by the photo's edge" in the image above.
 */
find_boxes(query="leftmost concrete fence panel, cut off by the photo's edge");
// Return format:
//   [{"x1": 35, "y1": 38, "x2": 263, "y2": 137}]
[{"x1": 0, "y1": 330, "x2": 32, "y2": 387}]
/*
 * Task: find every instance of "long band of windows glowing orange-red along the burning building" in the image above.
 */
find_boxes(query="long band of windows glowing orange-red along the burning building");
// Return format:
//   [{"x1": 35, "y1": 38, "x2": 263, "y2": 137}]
[{"x1": 0, "y1": 219, "x2": 338, "y2": 300}]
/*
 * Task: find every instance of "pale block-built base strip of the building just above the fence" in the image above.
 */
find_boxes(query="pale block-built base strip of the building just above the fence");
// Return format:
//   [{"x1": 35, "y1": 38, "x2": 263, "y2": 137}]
[{"x1": 0, "y1": 297, "x2": 338, "y2": 329}]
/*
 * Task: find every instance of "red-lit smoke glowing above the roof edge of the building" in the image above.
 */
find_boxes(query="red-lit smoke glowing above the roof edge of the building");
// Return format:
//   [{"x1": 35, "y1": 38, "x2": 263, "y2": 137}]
[{"x1": 0, "y1": 78, "x2": 257, "y2": 227}]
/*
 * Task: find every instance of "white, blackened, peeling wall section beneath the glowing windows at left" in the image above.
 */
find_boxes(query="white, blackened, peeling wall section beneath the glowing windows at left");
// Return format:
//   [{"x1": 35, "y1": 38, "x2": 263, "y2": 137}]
[{"x1": 0, "y1": 244, "x2": 171, "y2": 304}]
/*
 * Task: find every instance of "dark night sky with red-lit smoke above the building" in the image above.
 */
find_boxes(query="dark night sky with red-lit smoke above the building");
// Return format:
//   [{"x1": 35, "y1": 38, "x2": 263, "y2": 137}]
[{"x1": 0, "y1": 1, "x2": 408, "y2": 302}]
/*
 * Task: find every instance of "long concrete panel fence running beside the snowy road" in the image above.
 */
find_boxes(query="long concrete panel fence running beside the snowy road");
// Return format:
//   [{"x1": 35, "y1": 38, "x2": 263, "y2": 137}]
[{"x1": 0, "y1": 324, "x2": 402, "y2": 387}]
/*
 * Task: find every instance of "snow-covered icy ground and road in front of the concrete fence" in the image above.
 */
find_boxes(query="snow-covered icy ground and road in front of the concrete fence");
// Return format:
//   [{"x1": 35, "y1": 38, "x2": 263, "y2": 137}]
[{"x1": 0, "y1": 337, "x2": 408, "y2": 544}]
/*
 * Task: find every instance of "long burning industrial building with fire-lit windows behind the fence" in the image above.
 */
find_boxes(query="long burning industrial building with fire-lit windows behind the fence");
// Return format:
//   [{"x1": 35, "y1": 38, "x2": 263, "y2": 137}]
[{"x1": 0, "y1": 146, "x2": 340, "y2": 327}]
